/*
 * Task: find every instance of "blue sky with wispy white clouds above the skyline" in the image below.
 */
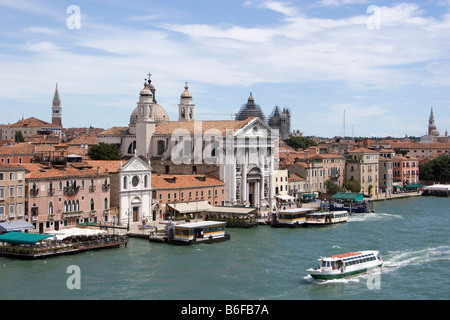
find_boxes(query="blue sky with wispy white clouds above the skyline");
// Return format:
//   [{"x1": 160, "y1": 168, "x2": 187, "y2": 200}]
[{"x1": 0, "y1": 0, "x2": 450, "y2": 138}]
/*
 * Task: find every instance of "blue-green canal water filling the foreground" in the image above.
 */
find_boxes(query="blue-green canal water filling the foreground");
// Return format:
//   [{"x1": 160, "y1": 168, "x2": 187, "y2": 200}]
[{"x1": 0, "y1": 197, "x2": 450, "y2": 300}]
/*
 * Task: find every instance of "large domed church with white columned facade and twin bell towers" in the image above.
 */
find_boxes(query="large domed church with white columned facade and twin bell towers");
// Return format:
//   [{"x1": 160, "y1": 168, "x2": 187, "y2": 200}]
[{"x1": 98, "y1": 76, "x2": 278, "y2": 207}]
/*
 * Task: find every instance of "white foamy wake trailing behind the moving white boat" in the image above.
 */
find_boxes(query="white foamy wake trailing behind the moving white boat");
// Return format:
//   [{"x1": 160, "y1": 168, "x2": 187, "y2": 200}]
[{"x1": 382, "y1": 246, "x2": 450, "y2": 273}]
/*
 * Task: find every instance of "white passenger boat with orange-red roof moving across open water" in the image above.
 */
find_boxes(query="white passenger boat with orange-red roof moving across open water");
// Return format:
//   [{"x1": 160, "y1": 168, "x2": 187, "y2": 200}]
[{"x1": 307, "y1": 251, "x2": 383, "y2": 280}]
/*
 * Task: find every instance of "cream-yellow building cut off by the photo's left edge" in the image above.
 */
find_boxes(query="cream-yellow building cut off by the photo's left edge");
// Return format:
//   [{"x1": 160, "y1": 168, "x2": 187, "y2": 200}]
[{"x1": 0, "y1": 163, "x2": 26, "y2": 222}]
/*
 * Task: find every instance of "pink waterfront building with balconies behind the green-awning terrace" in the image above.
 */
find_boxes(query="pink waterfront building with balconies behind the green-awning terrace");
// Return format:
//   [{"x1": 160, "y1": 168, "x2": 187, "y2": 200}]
[{"x1": 21, "y1": 162, "x2": 111, "y2": 233}]
